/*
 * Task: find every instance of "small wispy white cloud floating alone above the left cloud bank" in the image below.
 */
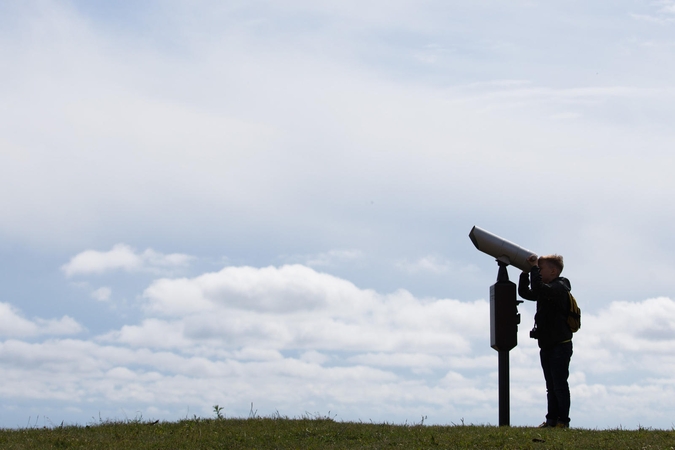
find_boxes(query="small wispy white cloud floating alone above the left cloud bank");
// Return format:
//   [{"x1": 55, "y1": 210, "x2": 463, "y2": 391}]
[{"x1": 61, "y1": 244, "x2": 194, "y2": 277}]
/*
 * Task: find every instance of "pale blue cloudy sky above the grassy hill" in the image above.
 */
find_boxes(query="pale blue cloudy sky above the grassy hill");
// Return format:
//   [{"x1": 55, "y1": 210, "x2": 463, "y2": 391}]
[{"x1": 0, "y1": 0, "x2": 675, "y2": 429}]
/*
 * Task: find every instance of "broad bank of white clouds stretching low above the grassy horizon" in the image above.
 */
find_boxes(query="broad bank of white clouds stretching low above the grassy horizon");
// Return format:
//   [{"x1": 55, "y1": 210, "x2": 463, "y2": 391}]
[{"x1": 0, "y1": 265, "x2": 675, "y2": 427}]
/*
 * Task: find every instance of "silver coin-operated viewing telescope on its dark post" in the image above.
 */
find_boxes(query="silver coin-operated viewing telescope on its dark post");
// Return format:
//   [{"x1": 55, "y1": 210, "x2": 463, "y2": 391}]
[{"x1": 469, "y1": 227, "x2": 534, "y2": 426}]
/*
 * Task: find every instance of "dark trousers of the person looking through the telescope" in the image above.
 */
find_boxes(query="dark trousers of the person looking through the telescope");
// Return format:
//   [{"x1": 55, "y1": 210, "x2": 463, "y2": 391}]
[{"x1": 539, "y1": 341, "x2": 572, "y2": 425}]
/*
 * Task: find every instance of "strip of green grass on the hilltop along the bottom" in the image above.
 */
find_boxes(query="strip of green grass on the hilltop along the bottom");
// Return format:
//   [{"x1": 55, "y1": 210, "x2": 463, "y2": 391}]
[{"x1": 0, "y1": 417, "x2": 675, "y2": 450}]
